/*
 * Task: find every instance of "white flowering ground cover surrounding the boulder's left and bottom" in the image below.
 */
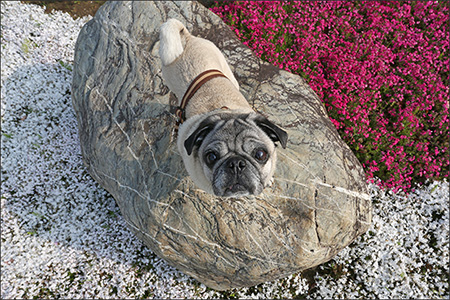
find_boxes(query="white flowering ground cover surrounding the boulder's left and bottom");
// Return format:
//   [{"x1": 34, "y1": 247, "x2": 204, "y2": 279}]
[{"x1": 0, "y1": 1, "x2": 450, "y2": 299}]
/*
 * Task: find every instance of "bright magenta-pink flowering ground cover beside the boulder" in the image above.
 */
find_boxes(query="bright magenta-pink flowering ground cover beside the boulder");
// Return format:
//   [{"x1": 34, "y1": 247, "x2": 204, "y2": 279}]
[{"x1": 211, "y1": 1, "x2": 449, "y2": 192}]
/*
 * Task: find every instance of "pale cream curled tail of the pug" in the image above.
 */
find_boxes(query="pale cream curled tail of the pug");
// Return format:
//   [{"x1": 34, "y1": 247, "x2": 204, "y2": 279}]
[{"x1": 159, "y1": 19, "x2": 190, "y2": 66}]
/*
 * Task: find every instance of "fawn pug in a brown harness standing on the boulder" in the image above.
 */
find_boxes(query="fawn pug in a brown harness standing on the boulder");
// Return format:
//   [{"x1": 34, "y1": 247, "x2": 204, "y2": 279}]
[{"x1": 159, "y1": 19, "x2": 288, "y2": 197}]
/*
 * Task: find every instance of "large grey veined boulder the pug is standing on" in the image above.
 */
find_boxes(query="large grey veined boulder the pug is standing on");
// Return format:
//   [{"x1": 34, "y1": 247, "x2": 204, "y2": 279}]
[{"x1": 72, "y1": 1, "x2": 371, "y2": 290}]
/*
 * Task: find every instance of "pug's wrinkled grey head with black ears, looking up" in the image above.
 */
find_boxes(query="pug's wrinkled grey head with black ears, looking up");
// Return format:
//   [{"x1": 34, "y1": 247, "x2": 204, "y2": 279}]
[{"x1": 184, "y1": 113, "x2": 287, "y2": 197}]
